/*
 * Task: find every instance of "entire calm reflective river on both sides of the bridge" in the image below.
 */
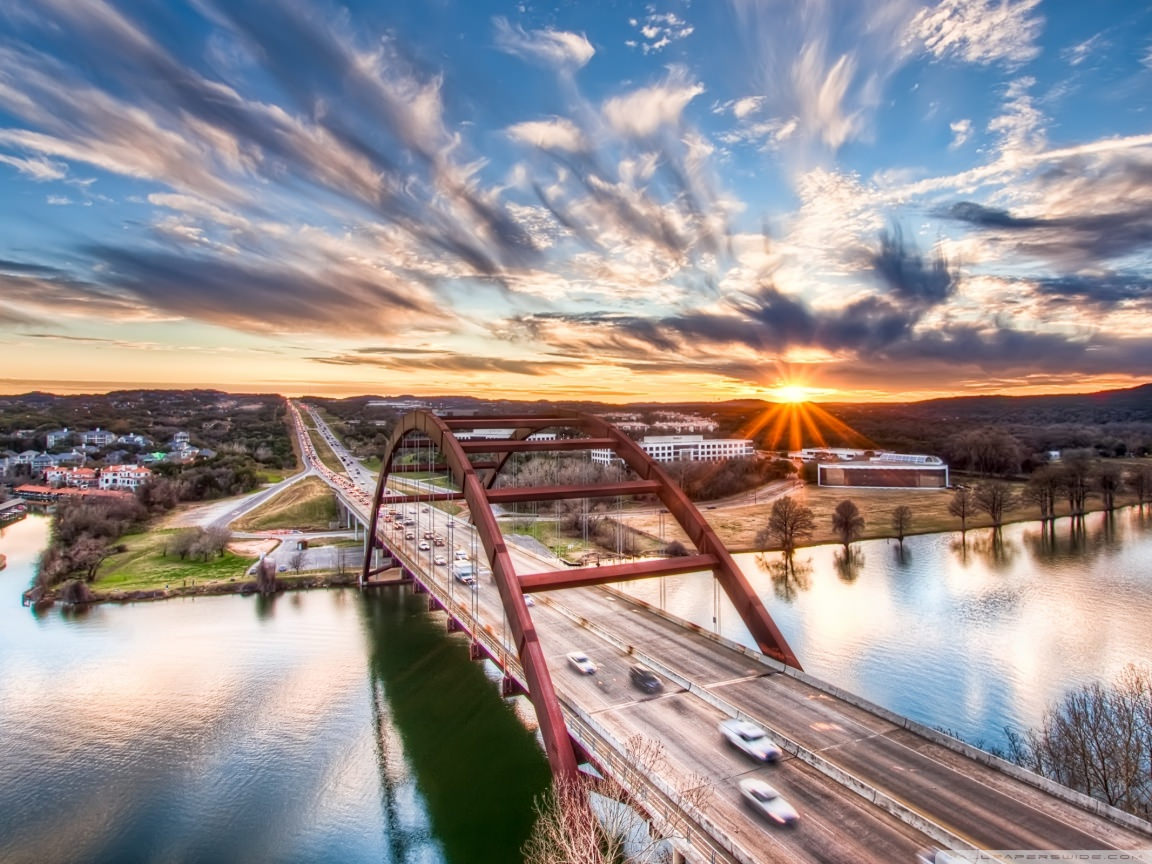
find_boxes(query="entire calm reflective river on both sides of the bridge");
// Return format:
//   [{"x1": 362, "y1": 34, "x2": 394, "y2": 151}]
[{"x1": 0, "y1": 508, "x2": 1152, "y2": 864}]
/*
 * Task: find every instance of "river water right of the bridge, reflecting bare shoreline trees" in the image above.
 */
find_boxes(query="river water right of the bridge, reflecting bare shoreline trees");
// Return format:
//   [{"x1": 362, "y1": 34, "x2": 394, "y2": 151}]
[{"x1": 628, "y1": 508, "x2": 1152, "y2": 745}]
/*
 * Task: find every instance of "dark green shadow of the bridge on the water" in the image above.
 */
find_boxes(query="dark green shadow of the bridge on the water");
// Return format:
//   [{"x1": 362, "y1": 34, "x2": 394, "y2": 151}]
[{"x1": 363, "y1": 586, "x2": 551, "y2": 864}]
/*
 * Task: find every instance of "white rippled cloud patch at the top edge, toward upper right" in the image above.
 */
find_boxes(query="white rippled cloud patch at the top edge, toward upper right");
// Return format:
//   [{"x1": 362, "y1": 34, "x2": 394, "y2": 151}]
[{"x1": 905, "y1": 0, "x2": 1044, "y2": 66}]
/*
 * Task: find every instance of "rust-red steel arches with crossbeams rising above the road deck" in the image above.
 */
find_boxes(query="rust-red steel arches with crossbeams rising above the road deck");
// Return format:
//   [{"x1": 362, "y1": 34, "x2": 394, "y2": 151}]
[{"x1": 362, "y1": 411, "x2": 799, "y2": 776}]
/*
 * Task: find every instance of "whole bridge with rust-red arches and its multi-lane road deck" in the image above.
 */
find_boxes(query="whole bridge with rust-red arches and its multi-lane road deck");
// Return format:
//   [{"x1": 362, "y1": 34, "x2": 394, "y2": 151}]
[{"x1": 290, "y1": 403, "x2": 1152, "y2": 862}]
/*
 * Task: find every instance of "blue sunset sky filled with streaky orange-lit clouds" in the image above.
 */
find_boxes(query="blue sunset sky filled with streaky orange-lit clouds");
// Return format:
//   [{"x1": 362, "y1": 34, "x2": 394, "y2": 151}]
[{"x1": 0, "y1": 0, "x2": 1152, "y2": 402}]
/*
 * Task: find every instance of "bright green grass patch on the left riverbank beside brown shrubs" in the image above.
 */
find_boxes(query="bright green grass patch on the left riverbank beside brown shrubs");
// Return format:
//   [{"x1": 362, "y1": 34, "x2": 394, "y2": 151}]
[{"x1": 92, "y1": 529, "x2": 253, "y2": 591}]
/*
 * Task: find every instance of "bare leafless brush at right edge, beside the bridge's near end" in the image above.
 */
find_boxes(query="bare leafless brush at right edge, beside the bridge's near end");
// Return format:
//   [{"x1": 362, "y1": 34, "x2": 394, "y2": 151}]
[{"x1": 1009, "y1": 665, "x2": 1152, "y2": 818}]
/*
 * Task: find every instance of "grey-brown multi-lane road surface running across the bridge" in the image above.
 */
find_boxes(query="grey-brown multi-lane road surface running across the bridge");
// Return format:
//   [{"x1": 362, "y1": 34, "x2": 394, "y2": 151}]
[{"x1": 290, "y1": 405, "x2": 1152, "y2": 862}]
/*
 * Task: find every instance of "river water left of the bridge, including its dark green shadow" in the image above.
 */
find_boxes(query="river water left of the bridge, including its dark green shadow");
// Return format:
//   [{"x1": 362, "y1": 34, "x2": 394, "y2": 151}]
[{"x1": 0, "y1": 517, "x2": 548, "y2": 864}]
